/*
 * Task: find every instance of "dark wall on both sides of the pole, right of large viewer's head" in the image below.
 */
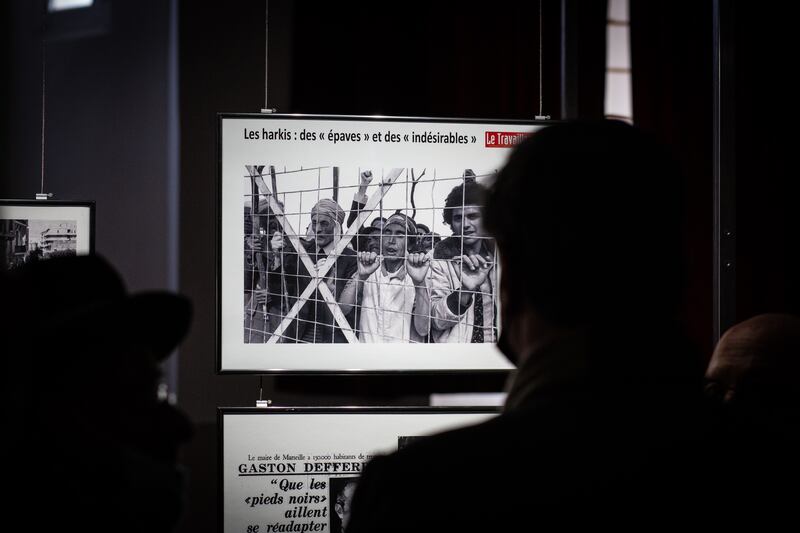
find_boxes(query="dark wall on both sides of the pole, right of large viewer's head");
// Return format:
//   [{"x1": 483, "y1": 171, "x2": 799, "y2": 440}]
[{"x1": 631, "y1": 0, "x2": 800, "y2": 355}]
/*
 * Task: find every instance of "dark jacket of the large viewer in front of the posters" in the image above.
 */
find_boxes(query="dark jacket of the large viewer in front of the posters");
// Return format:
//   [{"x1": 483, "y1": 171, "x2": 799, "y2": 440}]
[{"x1": 348, "y1": 326, "x2": 707, "y2": 533}]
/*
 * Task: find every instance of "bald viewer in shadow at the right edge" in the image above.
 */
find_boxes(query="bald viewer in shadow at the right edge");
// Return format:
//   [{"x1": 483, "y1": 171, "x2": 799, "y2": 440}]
[{"x1": 706, "y1": 313, "x2": 800, "y2": 520}]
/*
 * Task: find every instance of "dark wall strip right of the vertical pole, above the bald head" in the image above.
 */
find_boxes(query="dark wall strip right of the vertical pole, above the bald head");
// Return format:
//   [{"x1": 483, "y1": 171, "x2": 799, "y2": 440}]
[{"x1": 731, "y1": 1, "x2": 800, "y2": 320}]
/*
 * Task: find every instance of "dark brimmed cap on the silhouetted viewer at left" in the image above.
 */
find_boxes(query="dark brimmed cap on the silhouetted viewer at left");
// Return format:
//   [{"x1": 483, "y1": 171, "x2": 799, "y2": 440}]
[{"x1": 11, "y1": 255, "x2": 192, "y2": 364}]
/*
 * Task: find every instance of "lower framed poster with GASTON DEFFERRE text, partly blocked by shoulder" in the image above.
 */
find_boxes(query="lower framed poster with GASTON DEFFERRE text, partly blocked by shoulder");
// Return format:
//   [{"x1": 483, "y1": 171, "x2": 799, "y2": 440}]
[{"x1": 218, "y1": 407, "x2": 499, "y2": 533}]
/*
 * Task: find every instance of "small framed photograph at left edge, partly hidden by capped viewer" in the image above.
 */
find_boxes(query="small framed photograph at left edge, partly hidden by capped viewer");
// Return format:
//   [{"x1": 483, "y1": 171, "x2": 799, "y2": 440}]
[{"x1": 0, "y1": 200, "x2": 94, "y2": 269}]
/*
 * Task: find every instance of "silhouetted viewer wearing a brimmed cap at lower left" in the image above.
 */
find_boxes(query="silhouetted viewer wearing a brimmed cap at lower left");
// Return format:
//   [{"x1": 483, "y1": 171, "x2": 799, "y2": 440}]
[{"x1": 2, "y1": 257, "x2": 191, "y2": 532}]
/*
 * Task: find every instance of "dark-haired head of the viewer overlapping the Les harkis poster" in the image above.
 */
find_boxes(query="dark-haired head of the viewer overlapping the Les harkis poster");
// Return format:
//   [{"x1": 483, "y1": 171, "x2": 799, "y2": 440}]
[{"x1": 484, "y1": 120, "x2": 684, "y2": 326}]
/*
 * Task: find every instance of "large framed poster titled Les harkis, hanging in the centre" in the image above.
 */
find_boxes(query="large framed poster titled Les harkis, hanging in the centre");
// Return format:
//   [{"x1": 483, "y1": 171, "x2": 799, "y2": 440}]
[{"x1": 217, "y1": 114, "x2": 544, "y2": 373}]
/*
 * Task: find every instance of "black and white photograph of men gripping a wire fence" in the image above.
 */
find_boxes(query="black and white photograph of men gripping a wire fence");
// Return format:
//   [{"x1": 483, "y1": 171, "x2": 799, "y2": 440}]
[{"x1": 243, "y1": 165, "x2": 497, "y2": 344}]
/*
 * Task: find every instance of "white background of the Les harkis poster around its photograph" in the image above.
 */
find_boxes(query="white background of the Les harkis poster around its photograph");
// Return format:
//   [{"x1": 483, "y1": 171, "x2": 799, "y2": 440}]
[{"x1": 219, "y1": 115, "x2": 542, "y2": 372}]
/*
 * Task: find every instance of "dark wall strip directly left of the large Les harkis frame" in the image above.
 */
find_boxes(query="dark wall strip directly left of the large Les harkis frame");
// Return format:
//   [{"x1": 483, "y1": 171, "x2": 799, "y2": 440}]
[{"x1": 179, "y1": 1, "x2": 264, "y2": 423}]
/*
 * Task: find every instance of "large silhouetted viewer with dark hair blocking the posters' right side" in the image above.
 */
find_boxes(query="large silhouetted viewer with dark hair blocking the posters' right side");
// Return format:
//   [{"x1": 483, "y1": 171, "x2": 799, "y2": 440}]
[{"x1": 348, "y1": 121, "x2": 709, "y2": 533}]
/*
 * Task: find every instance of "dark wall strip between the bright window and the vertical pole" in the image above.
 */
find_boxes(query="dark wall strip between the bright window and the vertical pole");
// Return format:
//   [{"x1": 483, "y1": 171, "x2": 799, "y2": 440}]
[{"x1": 630, "y1": 0, "x2": 714, "y2": 354}]
